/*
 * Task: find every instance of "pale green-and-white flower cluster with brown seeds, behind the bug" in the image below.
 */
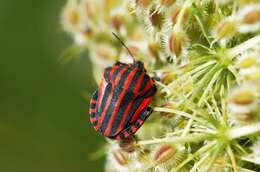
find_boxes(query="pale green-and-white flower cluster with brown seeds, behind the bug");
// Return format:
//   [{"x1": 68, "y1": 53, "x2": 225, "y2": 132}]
[{"x1": 61, "y1": 0, "x2": 260, "y2": 172}]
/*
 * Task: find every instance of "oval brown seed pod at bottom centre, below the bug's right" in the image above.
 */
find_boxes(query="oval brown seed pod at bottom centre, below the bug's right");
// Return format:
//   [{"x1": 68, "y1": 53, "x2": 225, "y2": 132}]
[{"x1": 154, "y1": 145, "x2": 177, "y2": 164}]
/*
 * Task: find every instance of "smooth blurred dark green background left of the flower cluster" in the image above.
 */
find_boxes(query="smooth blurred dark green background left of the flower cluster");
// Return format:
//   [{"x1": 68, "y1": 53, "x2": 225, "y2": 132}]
[{"x1": 0, "y1": 0, "x2": 104, "y2": 172}]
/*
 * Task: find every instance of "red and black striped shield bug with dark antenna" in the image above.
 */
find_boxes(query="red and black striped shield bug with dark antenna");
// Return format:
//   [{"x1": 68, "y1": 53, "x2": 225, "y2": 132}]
[{"x1": 90, "y1": 34, "x2": 156, "y2": 140}]
